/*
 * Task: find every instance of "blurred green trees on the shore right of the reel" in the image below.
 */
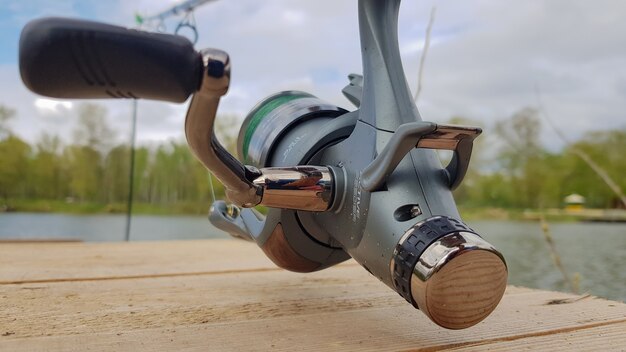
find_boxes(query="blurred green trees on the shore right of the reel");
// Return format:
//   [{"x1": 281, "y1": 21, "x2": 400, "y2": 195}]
[{"x1": 453, "y1": 108, "x2": 626, "y2": 209}]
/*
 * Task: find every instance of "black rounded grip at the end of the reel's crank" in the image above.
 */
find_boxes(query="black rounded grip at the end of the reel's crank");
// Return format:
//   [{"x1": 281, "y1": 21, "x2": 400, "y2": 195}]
[{"x1": 19, "y1": 18, "x2": 203, "y2": 102}]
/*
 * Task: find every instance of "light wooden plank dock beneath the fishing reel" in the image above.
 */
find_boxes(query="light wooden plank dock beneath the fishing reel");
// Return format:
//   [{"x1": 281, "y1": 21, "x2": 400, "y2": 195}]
[{"x1": 0, "y1": 240, "x2": 626, "y2": 352}]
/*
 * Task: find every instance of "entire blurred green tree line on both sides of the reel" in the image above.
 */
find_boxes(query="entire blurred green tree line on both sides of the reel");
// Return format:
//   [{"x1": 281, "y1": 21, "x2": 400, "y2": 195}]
[{"x1": 0, "y1": 104, "x2": 626, "y2": 213}]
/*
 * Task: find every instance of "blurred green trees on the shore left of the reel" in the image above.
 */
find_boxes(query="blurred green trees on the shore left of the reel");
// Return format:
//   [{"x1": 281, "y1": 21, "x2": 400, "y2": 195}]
[{"x1": 0, "y1": 104, "x2": 223, "y2": 212}]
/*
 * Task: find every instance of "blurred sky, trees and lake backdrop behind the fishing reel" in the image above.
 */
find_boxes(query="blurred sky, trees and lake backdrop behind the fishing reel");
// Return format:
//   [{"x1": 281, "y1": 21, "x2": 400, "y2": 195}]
[{"x1": 0, "y1": 0, "x2": 626, "y2": 301}]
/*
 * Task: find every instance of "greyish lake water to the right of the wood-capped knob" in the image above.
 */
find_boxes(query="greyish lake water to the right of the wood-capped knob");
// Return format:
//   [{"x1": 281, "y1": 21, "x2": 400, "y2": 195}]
[{"x1": 469, "y1": 221, "x2": 626, "y2": 302}]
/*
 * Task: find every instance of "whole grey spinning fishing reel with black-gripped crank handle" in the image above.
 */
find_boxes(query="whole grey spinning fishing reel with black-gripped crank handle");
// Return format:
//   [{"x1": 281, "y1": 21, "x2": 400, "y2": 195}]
[{"x1": 20, "y1": 0, "x2": 507, "y2": 329}]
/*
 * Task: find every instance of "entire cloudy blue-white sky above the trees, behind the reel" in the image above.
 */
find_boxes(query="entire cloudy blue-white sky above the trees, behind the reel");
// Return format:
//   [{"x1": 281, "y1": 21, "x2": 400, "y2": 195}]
[{"x1": 0, "y1": 0, "x2": 626, "y2": 149}]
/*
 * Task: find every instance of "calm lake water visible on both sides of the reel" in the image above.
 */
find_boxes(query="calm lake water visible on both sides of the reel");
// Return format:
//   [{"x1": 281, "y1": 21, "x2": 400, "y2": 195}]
[{"x1": 0, "y1": 213, "x2": 626, "y2": 302}]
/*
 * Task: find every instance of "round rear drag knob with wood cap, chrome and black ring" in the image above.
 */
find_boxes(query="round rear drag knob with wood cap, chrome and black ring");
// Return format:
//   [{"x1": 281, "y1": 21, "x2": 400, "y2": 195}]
[{"x1": 392, "y1": 217, "x2": 507, "y2": 329}]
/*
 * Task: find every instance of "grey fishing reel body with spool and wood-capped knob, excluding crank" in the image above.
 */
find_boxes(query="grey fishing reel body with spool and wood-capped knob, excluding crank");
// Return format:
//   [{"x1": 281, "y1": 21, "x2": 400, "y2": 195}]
[{"x1": 210, "y1": 1, "x2": 507, "y2": 329}]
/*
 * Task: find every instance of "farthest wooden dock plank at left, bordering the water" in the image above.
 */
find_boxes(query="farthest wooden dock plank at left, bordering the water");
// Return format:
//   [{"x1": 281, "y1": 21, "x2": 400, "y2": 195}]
[{"x1": 0, "y1": 239, "x2": 276, "y2": 284}]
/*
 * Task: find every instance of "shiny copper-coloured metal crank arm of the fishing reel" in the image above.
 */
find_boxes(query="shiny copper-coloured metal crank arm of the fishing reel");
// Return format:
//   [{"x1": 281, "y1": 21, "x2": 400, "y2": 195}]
[{"x1": 185, "y1": 49, "x2": 335, "y2": 211}]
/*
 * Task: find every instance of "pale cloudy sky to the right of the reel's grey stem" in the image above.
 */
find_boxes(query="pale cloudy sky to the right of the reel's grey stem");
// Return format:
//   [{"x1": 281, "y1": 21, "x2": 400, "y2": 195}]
[{"x1": 398, "y1": 1, "x2": 626, "y2": 147}]
